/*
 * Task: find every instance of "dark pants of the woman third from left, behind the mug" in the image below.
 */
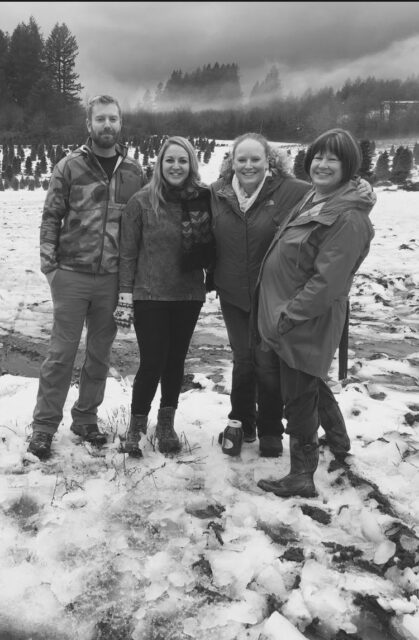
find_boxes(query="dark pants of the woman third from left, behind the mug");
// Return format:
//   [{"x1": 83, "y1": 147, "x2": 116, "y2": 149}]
[{"x1": 220, "y1": 299, "x2": 284, "y2": 438}]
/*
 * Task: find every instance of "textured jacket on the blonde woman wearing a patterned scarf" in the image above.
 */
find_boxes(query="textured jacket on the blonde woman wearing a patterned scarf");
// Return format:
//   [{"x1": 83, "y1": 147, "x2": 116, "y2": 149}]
[{"x1": 119, "y1": 186, "x2": 208, "y2": 301}]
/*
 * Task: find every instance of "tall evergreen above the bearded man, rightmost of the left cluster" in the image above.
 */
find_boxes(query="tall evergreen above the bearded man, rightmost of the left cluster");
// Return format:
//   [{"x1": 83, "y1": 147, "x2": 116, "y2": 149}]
[{"x1": 45, "y1": 22, "x2": 83, "y2": 104}]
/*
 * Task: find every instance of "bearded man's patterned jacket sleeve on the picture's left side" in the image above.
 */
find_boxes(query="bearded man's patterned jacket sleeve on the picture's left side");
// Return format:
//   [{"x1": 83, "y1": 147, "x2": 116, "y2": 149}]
[{"x1": 40, "y1": 158, "x2": 70, "y2": 284}]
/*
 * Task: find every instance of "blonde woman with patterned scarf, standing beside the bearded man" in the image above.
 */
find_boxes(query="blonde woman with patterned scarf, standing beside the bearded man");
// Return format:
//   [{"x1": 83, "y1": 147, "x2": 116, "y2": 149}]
[{"x1": 116, "y1": 136, "x2": 214, "y2": 457}]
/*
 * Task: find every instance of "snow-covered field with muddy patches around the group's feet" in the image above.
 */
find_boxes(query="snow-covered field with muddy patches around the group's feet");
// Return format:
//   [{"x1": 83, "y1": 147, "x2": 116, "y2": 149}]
[{"x1": 0, "y1": 147, "x2": 419, "y2": 640}]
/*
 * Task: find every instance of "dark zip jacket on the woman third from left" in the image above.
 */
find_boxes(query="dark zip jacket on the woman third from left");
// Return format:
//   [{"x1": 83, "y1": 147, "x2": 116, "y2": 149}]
[{"x1": 211, "y1": 170, "x2": 310, "y2": 311}]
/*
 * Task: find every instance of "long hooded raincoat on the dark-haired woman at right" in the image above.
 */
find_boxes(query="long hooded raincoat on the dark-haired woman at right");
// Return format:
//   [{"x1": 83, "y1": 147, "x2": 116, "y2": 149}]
[{"x1": 255, "y1": 182, "x2": 375, "y2": 377}]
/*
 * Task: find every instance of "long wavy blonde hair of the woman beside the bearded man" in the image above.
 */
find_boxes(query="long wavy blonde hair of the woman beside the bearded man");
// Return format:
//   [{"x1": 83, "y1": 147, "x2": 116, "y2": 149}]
[{"x1": 147, "y1": 136, "x2": 201, "y2": 214}]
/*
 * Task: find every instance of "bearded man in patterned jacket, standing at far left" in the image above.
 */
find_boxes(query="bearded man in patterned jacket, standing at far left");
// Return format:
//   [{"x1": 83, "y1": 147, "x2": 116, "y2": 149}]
[{"x1": 28, "y1": 95, "x2": 144, "y2": 460}]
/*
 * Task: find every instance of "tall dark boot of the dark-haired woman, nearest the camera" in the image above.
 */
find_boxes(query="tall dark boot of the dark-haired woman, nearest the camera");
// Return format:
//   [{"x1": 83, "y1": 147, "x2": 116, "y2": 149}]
[{"x1": 258, "y1": 433, "x2": 319, "y2": 498}]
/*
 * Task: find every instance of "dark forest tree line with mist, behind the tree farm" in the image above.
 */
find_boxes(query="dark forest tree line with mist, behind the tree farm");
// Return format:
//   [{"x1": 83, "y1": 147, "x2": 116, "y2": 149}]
[{"x1": 0, "y1": 17, "x2": 419, "y2": 145}]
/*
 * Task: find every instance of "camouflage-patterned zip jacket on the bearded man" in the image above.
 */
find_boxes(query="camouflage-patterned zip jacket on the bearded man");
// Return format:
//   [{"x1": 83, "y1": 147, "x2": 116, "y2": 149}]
[{"x1": 40, "y1": 140, "x2": 144, "y2": 274}]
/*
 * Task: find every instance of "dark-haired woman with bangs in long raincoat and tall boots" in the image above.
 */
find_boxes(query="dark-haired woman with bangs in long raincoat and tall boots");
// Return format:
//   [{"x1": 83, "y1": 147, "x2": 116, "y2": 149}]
[{"x1": 257, "y1": 129, "x2": 375, "y2": 497}]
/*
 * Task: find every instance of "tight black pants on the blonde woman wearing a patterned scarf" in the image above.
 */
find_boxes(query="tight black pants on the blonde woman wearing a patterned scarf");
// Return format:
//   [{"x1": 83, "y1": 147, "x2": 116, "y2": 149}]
[{"x1": 131, "y1": 300, "x2": 202, "y2": 415}]
